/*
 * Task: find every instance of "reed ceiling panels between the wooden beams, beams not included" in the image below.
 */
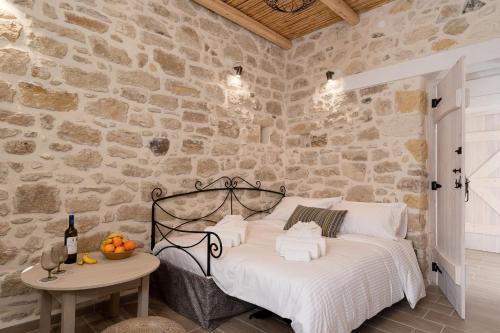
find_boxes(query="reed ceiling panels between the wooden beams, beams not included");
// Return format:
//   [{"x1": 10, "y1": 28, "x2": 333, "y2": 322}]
[{"x1": 222, "y1": 0, "x2": 392, "y2": 39}]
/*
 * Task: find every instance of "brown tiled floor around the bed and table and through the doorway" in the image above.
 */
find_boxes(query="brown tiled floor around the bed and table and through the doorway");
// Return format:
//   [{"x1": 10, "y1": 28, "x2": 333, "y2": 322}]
[{"x1": 29, "y1": 250, "x2": 500, "y2": 333}]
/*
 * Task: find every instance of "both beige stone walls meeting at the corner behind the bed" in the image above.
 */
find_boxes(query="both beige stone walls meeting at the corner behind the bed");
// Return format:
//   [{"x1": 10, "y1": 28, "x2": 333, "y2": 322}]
[{"x1": 0, "y1": 0, "x2": 500, "y2": 328}]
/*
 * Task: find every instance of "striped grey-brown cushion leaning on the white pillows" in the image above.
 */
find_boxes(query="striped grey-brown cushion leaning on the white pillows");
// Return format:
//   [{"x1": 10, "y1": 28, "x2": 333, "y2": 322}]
[{"x1": 283, "y1": 205, "x2": 347, "y2": 238}]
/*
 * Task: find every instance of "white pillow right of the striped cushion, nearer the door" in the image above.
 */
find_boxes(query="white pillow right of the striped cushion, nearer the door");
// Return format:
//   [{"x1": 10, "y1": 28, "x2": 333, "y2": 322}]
[{"x1": 332, "y1": 201, "x2": 408, "y2": 240}]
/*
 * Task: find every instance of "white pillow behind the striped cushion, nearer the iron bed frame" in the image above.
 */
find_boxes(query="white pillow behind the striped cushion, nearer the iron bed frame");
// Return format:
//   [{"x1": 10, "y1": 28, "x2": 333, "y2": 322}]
[{"x1": 263, "y1": 197, "x2": 342, "y2": 221}]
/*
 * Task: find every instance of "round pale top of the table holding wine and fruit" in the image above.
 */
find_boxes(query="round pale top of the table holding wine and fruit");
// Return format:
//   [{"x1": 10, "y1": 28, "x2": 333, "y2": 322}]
[{"x1": 21, "y1": 251, "x2": 160, "y2": 291}]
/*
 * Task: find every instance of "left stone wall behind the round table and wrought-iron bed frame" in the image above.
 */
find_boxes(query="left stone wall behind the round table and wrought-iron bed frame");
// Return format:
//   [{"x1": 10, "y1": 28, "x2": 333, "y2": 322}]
[{"x1": 0, "y1": 0, "x2": 285, "y2": 328}]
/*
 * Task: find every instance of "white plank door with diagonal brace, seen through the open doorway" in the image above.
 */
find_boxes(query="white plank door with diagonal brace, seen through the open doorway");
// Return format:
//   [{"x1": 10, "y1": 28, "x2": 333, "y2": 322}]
[{"x1": 465, "y1": 74, "x2": 500, "y2": 253}]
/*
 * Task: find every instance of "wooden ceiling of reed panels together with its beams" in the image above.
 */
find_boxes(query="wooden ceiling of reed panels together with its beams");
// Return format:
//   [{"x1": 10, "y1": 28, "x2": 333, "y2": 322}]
[{"x1": 193, "y1": 0, "x2": 392, "y2": 49}]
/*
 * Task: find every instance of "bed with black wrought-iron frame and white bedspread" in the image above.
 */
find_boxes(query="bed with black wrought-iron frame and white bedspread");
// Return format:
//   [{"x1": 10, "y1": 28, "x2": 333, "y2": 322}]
[{"x1": 152, "y1": 178, "x2": 425, "y2": 333}]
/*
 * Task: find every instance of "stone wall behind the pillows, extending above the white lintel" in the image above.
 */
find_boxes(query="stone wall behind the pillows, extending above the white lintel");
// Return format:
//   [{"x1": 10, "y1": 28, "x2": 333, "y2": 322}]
[{"x1": 285, "y1": 0, "x2": 500, "y2": 280}]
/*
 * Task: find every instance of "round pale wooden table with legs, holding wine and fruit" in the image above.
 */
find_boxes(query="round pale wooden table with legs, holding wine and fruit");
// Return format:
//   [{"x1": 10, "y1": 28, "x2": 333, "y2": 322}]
[{"x1": 21, "y1": 251, "x2": 160, "y2": 333}]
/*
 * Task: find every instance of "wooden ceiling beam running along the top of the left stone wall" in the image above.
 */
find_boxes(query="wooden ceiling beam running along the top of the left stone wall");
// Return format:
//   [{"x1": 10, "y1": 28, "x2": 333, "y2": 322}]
[{"x1": 194, "y1": 0, "x2": 292, "y2": 50}]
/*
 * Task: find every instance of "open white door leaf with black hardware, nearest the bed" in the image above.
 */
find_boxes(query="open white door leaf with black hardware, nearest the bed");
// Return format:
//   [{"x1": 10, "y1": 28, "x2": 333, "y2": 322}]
[{"x1": 432, "y1": 59, "x2": 465, "y2": 318}]
